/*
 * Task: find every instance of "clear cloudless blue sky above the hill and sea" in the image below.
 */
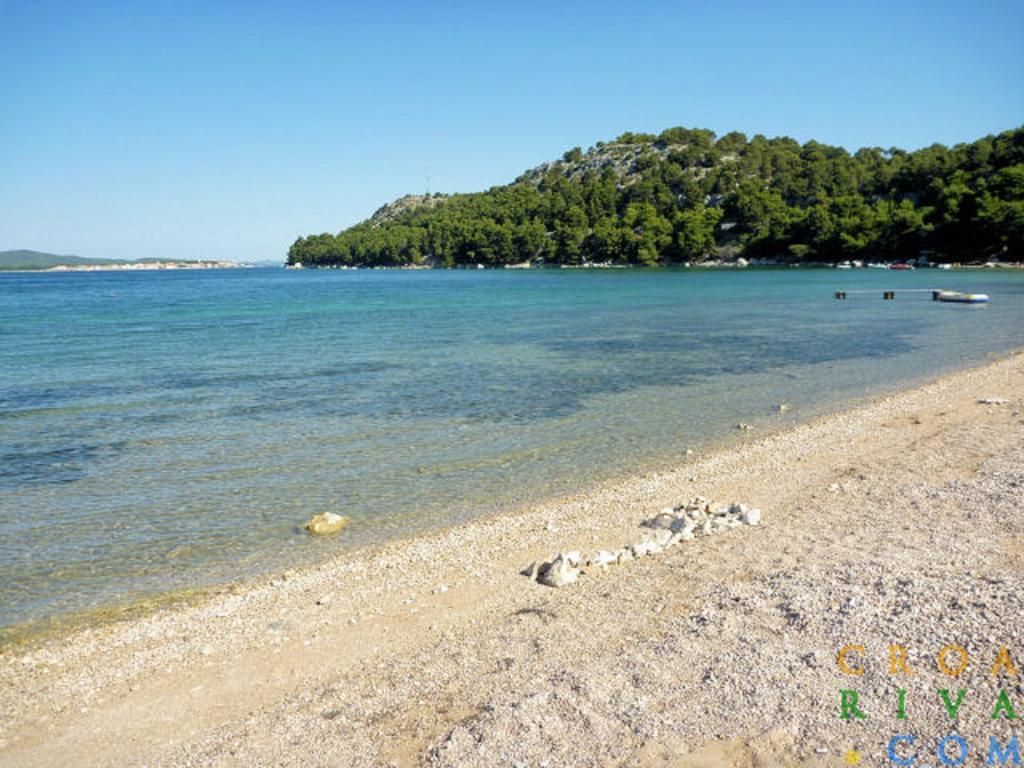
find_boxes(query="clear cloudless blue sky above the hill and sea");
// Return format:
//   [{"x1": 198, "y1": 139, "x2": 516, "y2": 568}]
[{"x1": 0, "y1": 0, "x2": 1024, "y2": 260}]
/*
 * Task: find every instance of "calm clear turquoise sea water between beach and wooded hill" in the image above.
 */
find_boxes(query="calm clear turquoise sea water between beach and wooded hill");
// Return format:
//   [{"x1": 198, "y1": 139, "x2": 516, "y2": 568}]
[{"x1": 0, "y1": 269, "x2": 1024, "y2": 627}]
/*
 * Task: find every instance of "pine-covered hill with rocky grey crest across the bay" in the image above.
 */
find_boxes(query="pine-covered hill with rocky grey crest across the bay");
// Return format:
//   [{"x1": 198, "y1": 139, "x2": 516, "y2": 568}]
[{"x1": 288, "y1": 128, "x2": 1024, "y2": 266}]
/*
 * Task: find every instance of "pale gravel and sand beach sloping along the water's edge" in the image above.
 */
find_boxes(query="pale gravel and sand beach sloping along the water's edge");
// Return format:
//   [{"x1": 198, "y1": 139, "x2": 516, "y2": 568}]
[{"x1": 0, "y1": 352, "x2": 1024, "y2": 768}]
